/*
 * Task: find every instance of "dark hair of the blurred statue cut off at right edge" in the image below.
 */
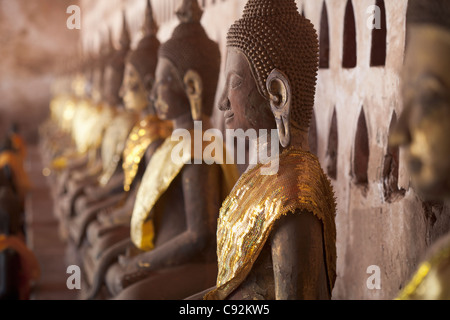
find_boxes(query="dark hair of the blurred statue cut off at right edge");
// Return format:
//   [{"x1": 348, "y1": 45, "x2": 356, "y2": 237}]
[{"x1": 406, "y1": 0, "x2": 450, "y2": 29}]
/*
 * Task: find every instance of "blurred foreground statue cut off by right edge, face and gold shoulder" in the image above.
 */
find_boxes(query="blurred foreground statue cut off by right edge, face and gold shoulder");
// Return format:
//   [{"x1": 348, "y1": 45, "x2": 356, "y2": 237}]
[{"x1": 390, "y1": 0, "x2": 450, "y2": 300}]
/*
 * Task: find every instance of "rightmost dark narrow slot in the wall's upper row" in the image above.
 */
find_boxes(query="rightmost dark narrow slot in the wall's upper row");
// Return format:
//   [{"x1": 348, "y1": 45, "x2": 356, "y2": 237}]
[{"x1": 370, "y1": 0, "x2": 387, "y2": 67}]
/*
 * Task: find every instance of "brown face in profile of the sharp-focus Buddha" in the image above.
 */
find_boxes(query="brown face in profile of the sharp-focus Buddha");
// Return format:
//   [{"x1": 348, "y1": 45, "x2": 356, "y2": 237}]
[{"x1": 219, "y1": 48, "x2": 276, "y2": 131}]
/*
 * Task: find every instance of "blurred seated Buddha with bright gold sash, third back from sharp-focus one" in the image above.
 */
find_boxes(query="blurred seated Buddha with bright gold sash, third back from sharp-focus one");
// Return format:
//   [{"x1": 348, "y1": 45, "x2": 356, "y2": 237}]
[{"x1": 78, "y1": 0, "x2": 172, "y2": 292}]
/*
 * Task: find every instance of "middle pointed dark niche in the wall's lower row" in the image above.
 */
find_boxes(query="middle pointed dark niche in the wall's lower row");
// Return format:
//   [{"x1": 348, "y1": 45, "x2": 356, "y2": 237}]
[{"x1": 353, "y1": 108, "x2": 370, "y2": 185}]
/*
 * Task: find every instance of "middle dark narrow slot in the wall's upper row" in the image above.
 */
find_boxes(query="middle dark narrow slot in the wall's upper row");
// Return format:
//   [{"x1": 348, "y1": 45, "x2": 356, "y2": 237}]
[{"x1": 342, "y1": 0, "x2": 357, "y2": 68}]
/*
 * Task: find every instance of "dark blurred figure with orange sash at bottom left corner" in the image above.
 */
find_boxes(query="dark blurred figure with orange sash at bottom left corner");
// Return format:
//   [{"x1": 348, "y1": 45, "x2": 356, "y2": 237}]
[{"x1": 0, "y1": 185, "x2": 40, "y2": 300}]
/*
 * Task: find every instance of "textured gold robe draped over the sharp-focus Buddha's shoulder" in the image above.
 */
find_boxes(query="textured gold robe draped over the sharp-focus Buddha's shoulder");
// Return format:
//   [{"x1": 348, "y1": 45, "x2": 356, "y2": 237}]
[{"x1": 204, "y1": 147, "x2": 336, "y2": 300}]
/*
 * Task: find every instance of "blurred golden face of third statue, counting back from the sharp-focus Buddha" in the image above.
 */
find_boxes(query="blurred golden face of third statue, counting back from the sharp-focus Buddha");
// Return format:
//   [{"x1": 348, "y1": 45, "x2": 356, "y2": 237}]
[{"x1": 120, "y1": 63, "x2": 148, "y2": 111}]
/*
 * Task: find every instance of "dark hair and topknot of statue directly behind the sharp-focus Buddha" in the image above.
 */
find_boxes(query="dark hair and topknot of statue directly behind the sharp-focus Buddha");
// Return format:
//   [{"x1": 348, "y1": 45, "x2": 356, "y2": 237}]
[{"x1": 159, "y1": 0, "x2": 220, "y2": 116}]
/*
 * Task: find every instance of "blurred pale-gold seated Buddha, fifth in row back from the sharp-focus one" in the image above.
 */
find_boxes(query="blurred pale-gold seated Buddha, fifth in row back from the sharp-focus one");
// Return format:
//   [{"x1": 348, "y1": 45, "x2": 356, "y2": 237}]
[{"x1": 50, "y1": 39, "x2": 114, "y2": 238}]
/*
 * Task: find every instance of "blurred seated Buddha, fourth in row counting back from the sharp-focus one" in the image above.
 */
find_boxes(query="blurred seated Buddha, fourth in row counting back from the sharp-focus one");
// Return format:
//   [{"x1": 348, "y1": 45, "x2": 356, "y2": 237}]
[{"x1": 56, "y1": 14, "x2": 132, "y2": 245}]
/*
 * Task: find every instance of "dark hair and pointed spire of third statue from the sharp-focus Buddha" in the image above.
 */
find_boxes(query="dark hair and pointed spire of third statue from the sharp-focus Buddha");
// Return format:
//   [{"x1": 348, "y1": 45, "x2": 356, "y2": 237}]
[{"x1": 126, "y1": 0, "x2": 160, "y2": 85}]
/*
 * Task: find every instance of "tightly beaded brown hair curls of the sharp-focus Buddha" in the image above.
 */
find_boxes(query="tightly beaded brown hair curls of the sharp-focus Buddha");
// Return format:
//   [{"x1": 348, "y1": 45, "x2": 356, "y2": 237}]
[{"x1": 227, "y1": 0, "x2": 319, "y2": 131}]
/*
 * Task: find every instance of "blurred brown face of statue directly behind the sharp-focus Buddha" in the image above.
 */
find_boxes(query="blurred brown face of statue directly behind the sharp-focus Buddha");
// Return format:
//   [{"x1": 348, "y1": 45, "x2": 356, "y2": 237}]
[{"x1": 150, "y1": 57, "x2": 191, "y2": 120}]
